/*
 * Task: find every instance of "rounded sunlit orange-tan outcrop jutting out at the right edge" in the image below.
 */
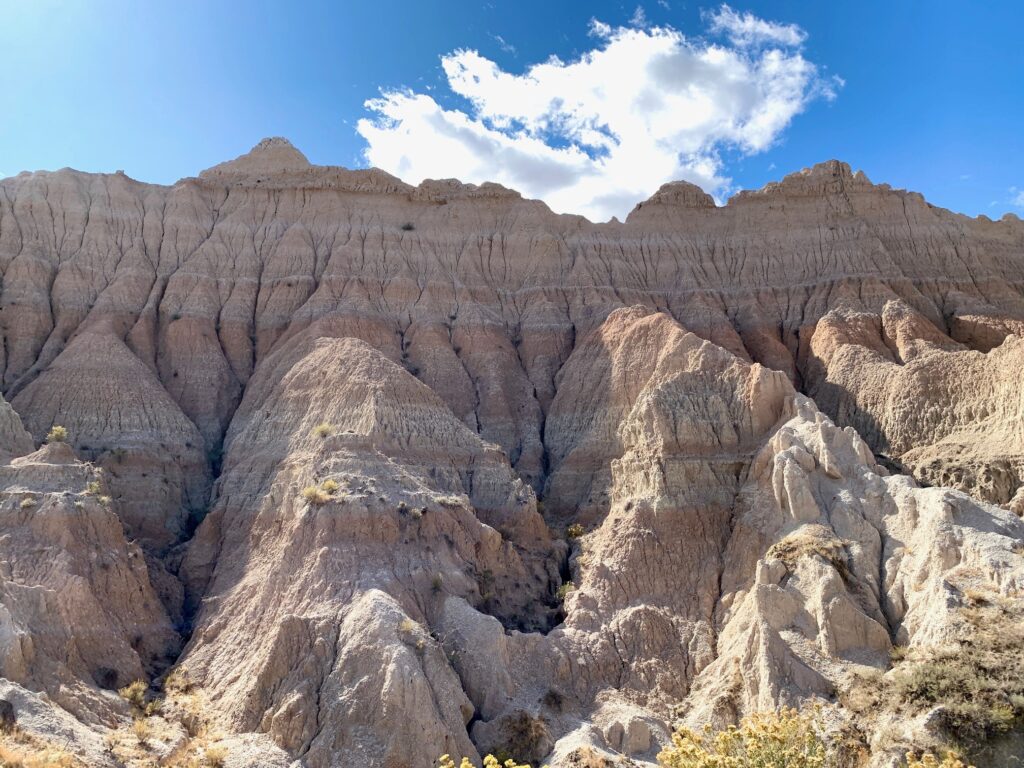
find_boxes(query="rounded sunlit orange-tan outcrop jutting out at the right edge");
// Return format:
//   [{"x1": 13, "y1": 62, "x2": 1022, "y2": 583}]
[{"x1": 807, "y1": 301, "x2": 1024, "y2": 505}]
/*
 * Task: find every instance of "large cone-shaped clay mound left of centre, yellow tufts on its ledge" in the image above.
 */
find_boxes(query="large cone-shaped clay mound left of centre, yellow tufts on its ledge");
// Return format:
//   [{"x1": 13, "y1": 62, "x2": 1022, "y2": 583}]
[{"x1": 182, "y1": 327, "x2": 557, "y2": 766}]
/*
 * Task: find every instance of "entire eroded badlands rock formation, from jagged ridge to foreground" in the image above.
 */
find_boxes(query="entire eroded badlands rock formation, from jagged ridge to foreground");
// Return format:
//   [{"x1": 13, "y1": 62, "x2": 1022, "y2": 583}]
[{"x1": 0, "y1": 139, "x2": 1024, "y2": 768}]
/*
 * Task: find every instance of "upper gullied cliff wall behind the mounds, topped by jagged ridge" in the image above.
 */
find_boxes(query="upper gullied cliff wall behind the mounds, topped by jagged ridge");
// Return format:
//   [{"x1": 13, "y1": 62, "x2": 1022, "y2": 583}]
[{"x1": 0, "y1": 139, "x2": 1024, "y2": 505}]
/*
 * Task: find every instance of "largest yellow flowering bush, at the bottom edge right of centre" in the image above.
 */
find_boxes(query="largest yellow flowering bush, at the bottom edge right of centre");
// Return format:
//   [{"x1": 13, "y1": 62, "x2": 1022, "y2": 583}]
[{"x1": 657, "y1": 709, "x2": 825, "y2": 768}]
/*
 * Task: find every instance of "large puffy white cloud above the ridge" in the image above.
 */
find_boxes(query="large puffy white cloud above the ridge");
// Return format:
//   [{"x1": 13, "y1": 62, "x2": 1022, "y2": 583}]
[{"x1": 357, "y1": 6, "x2": 839, "y2": 220}]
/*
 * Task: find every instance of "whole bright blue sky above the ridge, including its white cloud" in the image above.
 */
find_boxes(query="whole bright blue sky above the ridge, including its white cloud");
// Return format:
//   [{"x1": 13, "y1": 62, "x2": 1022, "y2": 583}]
[{"x1": 0, "y1": 0, "x2": 1024, "y2": 218}]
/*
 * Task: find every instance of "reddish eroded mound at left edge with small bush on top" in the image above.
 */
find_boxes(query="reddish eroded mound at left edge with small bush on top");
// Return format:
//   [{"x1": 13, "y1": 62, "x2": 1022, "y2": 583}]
[{"x1": 0, "y1": 403, "x2": 179, "y2": 765}]
